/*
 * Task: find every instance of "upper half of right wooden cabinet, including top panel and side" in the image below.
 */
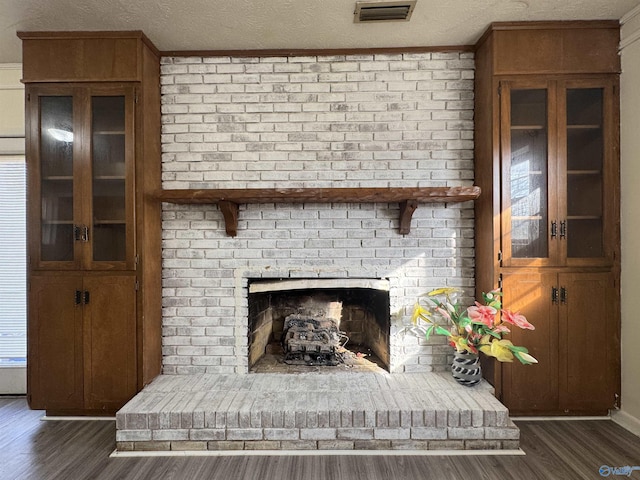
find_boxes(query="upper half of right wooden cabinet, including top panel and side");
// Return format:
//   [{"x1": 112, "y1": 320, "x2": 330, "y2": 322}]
[{"x1": 474, "y1": 21, "x2": 620, "y2": 292}]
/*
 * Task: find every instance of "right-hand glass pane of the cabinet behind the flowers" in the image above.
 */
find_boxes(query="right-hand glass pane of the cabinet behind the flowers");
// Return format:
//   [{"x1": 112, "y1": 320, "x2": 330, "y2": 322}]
[{"x1": 566, "y1": 88, "x2": 604, "y2": 258}]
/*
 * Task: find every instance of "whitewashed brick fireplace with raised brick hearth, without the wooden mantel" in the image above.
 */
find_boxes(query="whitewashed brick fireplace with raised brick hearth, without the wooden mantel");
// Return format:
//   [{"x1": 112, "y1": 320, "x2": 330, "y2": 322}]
[{"x1": 116, "y1": 48, "x2": 519, "y2": 453}]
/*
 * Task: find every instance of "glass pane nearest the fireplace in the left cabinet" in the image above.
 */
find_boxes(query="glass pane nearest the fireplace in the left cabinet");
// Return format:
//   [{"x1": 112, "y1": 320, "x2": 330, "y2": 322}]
[{"x1": 91, "y1": 96, "x2": 127, "y2": 261}]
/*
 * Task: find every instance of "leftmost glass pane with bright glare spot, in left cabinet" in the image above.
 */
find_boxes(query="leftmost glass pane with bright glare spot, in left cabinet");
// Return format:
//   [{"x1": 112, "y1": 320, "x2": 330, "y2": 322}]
[{"x1": 40, "y1": 97, "x2": 73, "y2": 261}]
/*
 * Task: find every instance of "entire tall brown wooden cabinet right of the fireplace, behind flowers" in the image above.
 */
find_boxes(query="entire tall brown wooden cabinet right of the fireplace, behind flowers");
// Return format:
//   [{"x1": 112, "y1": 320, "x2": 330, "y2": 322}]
[{"x1": 475, "y1": 22, "x2": 620, "y2": 414}]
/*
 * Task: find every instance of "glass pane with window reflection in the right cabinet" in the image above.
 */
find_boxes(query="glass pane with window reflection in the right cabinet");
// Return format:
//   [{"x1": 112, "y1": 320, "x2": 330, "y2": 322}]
[{"x1": 510, "y1": 89, "x2": 549, "y2": 258}]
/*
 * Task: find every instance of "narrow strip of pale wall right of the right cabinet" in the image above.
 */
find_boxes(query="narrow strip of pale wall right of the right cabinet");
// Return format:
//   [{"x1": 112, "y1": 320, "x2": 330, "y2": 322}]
[{"x1": 614, "y1": 7, "x2": 640, "y2": 434}]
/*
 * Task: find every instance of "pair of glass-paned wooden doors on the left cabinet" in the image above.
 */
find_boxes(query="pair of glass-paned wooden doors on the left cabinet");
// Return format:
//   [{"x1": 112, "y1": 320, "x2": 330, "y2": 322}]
[{"x1": 27, "y1": 85, "x2": 135, "y2": 270}]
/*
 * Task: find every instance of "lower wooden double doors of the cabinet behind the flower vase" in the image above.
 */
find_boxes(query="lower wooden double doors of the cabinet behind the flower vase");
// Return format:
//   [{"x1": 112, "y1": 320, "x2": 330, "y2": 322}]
[{"x1": 502, "y1": 272, "x2": 619, "y2": 415}]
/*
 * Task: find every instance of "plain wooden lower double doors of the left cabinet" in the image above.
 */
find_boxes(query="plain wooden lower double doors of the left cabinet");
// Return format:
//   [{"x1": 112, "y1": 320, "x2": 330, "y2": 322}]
[{"x1": 27, "y1": 273, "x2": 137, "y2": 414}]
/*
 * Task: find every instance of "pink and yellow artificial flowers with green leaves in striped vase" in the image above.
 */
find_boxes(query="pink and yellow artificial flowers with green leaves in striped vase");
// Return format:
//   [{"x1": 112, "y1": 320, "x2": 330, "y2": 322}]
[{"x1": 411, "y1": 288, "x2": 538, "y2": 365}]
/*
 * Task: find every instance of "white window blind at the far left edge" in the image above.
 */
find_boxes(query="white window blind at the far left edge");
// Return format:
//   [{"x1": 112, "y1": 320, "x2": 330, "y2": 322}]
[{"x1": 0, "y1": 156, "x2": 27, "y2": 367}]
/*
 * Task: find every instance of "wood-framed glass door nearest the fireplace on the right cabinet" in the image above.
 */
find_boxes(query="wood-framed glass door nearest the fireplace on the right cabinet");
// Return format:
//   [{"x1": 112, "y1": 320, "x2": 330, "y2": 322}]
[{"x1": 502, "y1": 84, "x2": 555, "y2": 265}]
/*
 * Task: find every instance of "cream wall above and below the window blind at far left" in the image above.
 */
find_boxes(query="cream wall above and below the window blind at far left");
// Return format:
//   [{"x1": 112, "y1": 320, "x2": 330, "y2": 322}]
[{"x1": 0, "y1": 64, "x2": 27, "y2": 394}]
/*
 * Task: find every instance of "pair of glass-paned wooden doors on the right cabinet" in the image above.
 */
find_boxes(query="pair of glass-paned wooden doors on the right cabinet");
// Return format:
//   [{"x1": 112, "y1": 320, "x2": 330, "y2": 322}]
[{"x1": 499, "y1": 78, "x2": 617, "y2": 267}]
